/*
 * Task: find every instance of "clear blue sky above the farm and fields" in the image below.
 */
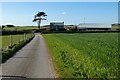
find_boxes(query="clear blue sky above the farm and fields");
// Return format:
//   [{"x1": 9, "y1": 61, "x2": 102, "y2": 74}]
[{"x1": 0, "y1": 2, "x2": 118, "y2": 26}]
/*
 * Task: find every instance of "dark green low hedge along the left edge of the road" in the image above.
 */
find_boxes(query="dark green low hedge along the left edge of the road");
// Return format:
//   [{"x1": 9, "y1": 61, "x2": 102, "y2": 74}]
[{"x1": 0, "y1": 36, "x2": 34, "y2": 63}]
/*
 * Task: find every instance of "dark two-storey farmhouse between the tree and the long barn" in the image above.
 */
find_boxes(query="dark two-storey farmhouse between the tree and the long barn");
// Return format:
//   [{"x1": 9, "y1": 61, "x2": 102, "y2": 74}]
[{"x1": 50, "y1": 22, "x2": 64, "y2": 30}]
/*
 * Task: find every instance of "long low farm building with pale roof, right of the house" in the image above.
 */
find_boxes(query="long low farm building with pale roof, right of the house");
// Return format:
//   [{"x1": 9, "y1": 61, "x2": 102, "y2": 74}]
[{"x1": 78, "y1": 23, "x2": 112, "y2": 30}]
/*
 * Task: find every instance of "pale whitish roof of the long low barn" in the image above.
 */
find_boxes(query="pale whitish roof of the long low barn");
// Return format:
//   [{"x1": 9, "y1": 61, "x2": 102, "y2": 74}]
[{"x1": 78, "y1": 23, "x2": 112, "y2": 28}]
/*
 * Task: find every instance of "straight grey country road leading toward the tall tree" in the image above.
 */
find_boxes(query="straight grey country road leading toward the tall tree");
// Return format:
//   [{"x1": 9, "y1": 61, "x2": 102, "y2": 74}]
[{"x1": 0, "y1": 34, "x2": 55, "y2": 78}]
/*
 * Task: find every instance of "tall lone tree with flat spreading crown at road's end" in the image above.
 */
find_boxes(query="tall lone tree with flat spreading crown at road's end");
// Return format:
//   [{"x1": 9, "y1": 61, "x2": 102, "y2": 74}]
[{"x1": 33, "y1": 12, "x2": 47, "y2": 29}]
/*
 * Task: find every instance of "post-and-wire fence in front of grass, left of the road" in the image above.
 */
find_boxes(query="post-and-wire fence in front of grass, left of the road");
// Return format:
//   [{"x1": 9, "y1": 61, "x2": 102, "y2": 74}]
[{"x1": 0, "y1": 33, "x2": 34, "y2": 50}]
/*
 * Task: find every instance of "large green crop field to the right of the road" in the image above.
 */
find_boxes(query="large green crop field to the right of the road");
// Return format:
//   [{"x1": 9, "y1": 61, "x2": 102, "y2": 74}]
[{"x1": 43, "y1": 33, "x2": 119, "y2": 79}]
